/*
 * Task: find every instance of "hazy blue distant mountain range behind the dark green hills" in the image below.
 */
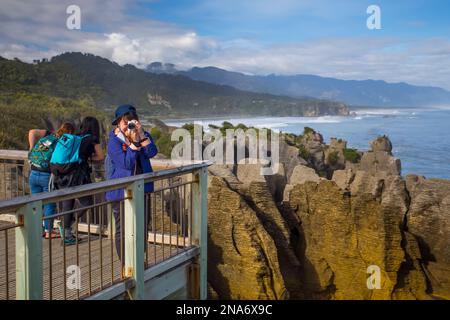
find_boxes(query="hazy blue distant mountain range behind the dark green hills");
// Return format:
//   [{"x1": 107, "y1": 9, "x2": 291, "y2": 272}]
[{"x1": 144, "y1": 64, "x2": 450, "y2": 107}]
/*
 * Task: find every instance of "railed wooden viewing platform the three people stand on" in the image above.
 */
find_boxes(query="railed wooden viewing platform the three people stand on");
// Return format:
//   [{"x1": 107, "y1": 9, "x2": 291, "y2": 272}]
[{"x1": 0, "y1": 150, "x2": 210, "y2": 300}]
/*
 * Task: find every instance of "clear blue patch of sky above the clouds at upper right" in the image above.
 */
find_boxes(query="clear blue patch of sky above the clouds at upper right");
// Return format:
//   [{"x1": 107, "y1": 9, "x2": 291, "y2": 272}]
[{"x1": 141, "y1": 0, "x2": 450, "y2": 44}]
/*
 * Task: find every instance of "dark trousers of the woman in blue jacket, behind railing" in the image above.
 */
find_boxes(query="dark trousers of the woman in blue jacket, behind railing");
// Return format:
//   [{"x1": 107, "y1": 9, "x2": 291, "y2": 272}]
[{"x1": 112, "y1": 198, "x2": 151, "y2": 262}]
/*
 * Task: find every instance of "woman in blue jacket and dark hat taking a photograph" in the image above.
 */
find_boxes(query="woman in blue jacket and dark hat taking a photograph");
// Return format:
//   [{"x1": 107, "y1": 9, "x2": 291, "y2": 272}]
[{"x1": 106, "y1": 105, "x2": 158, "y2": 260}]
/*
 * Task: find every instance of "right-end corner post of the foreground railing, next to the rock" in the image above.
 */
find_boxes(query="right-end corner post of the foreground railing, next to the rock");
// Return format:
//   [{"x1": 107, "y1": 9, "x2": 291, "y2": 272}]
[{"x1": 192, "y1": 167, "x2": 208, "y2": 300}]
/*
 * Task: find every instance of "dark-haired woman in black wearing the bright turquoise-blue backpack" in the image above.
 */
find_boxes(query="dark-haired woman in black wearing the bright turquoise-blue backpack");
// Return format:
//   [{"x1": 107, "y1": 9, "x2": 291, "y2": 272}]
[{"x1": 50, "y1": 117, "x2": 104, "y2": 245}]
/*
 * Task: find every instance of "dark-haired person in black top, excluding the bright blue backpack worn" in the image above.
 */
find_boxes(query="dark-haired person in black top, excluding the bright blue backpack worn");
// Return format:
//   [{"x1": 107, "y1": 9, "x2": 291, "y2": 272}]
[{"x1": 52, "y1": 117, "x2": 104, "y2": 245}]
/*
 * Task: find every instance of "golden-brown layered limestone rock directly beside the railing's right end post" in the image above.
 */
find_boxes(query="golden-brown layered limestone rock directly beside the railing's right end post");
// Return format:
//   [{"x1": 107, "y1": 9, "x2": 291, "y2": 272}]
[{"x1": 208, "y1": 176, "x2": 288, "y2": 299}]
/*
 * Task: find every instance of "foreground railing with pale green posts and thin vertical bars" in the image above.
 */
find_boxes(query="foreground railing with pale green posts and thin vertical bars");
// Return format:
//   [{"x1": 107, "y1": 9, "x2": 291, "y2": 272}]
[{"x1": 0, "y1": 163, "x2": 209, "y2": 299}]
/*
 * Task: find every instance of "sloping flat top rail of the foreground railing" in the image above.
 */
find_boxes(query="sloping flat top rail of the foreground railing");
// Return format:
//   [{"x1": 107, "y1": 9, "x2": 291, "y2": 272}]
[{"x1": 0, "y1": 161, "x2": 212, "y2": 214}]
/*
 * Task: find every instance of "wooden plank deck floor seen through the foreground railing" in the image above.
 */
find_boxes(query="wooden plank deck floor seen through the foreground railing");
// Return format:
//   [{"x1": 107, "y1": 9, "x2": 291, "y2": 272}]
[{"x1": 0, "y1": 229, "x2": 191, "y2": 300}]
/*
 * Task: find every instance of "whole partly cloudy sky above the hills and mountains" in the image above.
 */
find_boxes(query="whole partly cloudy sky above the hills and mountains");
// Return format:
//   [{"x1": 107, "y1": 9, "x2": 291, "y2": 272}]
[{"x1": 0, "y1": 0, "x2": 450, "y2": 90}]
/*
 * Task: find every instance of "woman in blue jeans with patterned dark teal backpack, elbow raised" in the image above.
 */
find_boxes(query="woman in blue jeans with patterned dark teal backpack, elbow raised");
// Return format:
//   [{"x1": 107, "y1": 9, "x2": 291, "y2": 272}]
[{"x1": 28, "y1": 122, "x2": 75, "y2": 239}]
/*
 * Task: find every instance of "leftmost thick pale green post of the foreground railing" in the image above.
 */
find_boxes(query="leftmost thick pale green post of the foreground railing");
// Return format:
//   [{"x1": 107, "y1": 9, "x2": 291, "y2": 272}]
[{"x1": 16, "y1": 201, "x2": 43, "y2": 300}]
